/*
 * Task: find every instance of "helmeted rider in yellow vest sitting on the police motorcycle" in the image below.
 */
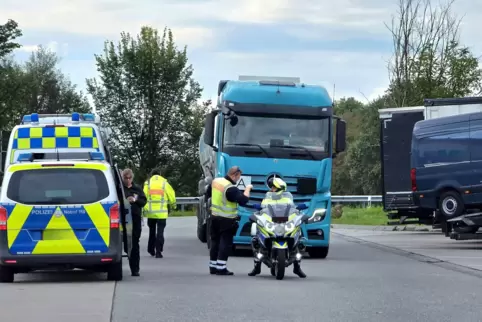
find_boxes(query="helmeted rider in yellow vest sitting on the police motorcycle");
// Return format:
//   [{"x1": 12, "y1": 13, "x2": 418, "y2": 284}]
[{"x1": 248, "y1": 177, "x2": 306, "y2": 278}]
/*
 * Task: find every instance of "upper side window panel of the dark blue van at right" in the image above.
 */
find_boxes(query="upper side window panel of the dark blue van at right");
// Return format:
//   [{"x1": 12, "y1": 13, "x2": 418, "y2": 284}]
[{"x1": 417, "y1": 129, "x2": 470, "y2": 167}]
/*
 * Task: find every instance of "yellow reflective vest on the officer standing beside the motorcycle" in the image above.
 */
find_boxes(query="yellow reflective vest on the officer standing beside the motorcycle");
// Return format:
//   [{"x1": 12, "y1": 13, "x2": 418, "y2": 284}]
[{"x1": 211, "y1": 178, "x2": 238, "y2": 218}]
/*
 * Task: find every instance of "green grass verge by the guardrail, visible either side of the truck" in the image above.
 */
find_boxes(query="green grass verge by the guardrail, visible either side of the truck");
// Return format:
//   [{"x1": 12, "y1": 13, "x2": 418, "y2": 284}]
[{"x1": 169, "y1": 206, "x2": 387, "y2": 226}]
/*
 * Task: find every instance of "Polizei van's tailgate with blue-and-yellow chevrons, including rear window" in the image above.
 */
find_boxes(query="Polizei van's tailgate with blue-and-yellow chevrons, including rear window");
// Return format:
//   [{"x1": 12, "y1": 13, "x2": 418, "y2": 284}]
[{"x1": 7, "y1": 167, "x2": 111, "y2": 255}]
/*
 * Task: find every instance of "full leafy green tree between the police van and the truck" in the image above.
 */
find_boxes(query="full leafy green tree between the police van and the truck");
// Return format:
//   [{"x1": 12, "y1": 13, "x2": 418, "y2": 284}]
[{"x1": 87, "y1": 27, "x2": 202, "y2": 188}]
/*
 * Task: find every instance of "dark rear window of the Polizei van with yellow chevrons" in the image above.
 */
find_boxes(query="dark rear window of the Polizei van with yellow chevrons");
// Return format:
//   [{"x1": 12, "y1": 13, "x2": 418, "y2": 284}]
[{"x1": 7, "y1": 168, "x2": 109, "y2": 205}]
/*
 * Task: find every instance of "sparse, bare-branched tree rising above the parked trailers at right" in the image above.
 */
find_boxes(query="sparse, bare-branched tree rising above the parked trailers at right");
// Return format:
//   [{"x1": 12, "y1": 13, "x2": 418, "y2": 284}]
[{"x1": 388, "y1": 0, "x2": 482, "y2": 106}]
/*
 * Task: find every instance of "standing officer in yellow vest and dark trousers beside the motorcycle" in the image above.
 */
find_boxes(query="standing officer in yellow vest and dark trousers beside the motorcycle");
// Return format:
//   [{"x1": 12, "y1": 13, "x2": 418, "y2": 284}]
[{"x1": 206, "y1": 166, "x2": 253, "y2": 275}]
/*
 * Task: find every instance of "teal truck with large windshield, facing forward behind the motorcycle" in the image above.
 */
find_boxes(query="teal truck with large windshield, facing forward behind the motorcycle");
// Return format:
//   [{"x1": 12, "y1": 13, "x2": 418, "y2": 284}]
[{"x1": 197, "y1": 80, "x2": 346, "y2": 258}]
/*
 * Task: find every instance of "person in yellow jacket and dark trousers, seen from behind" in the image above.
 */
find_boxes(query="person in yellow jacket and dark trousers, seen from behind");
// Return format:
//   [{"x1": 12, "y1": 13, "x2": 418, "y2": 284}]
[{"x1": 144, "y1": 169, "x2": 176, "y2": 258}]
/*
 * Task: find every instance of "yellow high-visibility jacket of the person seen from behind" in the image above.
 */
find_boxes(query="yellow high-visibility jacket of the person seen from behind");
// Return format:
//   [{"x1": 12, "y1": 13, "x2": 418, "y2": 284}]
[{"x1": 143, "y1": 175, "x2": 176, "y2": 219}]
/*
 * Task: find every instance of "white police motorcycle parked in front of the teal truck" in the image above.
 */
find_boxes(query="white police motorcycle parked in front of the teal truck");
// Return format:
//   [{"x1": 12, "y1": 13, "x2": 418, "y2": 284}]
[{"x1": 249, "y1": 204, "x2": 326, "y2": 280}]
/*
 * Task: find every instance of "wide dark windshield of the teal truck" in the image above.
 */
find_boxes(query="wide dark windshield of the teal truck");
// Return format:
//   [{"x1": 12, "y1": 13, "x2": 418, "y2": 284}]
[{"x1": 223, "y1": 116, "x2": 330, "y2": 152}]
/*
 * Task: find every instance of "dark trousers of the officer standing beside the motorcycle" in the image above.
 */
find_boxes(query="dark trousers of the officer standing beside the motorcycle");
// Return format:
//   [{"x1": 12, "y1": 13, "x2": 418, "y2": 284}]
[{"x1": 209, "y1": 216, "x2": 238, "y2": 269}]
